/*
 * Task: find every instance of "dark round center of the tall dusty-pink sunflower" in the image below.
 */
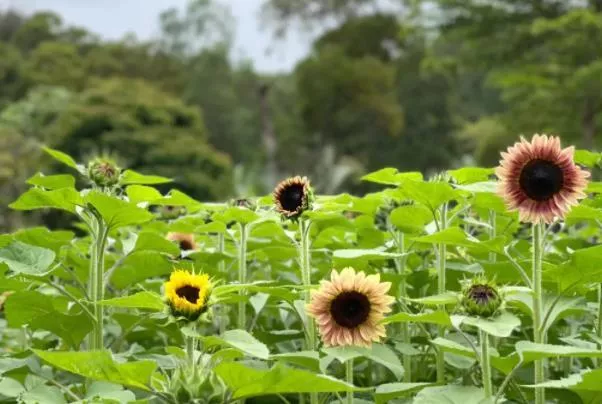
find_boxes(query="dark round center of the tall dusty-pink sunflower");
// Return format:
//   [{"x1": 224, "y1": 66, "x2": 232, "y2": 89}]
[{"x1": 519, "y1": 160, "x2": 564, "y2": 201}]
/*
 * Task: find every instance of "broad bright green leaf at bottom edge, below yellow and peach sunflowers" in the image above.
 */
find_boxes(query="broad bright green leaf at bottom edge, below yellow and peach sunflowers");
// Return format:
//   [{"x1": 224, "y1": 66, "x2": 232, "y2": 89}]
[{"x1": 215, "y1": 362, "x2": 368, "y2": 399}]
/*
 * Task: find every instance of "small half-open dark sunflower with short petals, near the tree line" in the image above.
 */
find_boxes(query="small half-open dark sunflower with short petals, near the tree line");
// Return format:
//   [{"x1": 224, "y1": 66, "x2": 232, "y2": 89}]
[{"x1": 272, "y1": 176, "x2": 313, "y2": 219}]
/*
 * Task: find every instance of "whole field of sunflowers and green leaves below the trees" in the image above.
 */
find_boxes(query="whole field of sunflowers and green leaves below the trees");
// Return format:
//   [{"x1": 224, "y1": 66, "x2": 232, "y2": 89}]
[{"x1": 0, "y1": 135, "x2": 602, "y2": 404}]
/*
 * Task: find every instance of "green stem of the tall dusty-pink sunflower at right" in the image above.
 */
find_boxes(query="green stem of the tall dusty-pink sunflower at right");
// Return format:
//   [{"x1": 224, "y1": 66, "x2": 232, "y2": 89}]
[{"x1": 532, "y1": 223, "x2": 545, "y2": 404}]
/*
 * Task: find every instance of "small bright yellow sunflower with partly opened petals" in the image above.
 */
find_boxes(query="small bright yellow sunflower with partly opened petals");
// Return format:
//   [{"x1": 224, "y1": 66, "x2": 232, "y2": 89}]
[{"x1": 165, "y1": 270, "x2": 212, "y2": 321}]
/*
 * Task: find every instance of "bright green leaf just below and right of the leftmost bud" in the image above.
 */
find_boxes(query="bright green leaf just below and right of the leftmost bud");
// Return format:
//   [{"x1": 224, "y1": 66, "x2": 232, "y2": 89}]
[{"x1": 86, "y1": 191, "x2": 154, "y2": 229}]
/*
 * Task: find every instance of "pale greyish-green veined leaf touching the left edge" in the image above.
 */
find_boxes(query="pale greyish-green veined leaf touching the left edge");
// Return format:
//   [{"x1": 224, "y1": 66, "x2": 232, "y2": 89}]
[{"x1": 0, "y1": 241, "x2": 56, "y2": 276}]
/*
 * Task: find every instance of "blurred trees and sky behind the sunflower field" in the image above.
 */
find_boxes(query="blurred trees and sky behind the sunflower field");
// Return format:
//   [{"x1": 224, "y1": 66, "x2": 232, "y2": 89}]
[{"x1": 0, "y1": 0, "x2": 602, "y2": 231}]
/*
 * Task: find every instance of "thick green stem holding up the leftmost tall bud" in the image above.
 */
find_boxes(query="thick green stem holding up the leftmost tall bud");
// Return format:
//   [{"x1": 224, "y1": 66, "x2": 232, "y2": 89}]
[{"x1": 88, "y1": 217, "x2": 109, "y2": 351}]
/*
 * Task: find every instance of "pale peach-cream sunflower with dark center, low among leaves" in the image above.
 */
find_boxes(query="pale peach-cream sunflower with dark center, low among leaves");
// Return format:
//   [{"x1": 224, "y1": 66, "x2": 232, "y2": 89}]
[{"x1": 307, "y1": 268, "x2": 394, "y2": 346}]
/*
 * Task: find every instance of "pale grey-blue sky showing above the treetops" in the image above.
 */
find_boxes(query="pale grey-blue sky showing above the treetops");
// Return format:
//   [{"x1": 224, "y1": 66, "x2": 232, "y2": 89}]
[{"x1": 0, "y1": 0, "x2": 312, "y2": 72}]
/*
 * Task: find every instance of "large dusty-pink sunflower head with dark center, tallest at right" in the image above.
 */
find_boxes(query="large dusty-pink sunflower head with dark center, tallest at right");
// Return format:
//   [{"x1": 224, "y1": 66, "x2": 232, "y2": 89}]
[{"x1": 496, "y1": 135, "x2": 590, "y2": 223}]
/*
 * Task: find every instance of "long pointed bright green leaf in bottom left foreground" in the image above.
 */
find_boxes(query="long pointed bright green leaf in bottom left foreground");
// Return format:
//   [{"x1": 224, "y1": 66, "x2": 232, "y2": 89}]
[{"x1": 33, "y1": 349, "x2": 157, "y2": 391}]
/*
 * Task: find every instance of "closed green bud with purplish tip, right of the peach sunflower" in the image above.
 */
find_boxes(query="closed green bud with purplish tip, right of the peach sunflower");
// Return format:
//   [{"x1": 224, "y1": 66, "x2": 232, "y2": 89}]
[{"x1": 462, "y1": 278, "x2": 503, "y2": 318}]
